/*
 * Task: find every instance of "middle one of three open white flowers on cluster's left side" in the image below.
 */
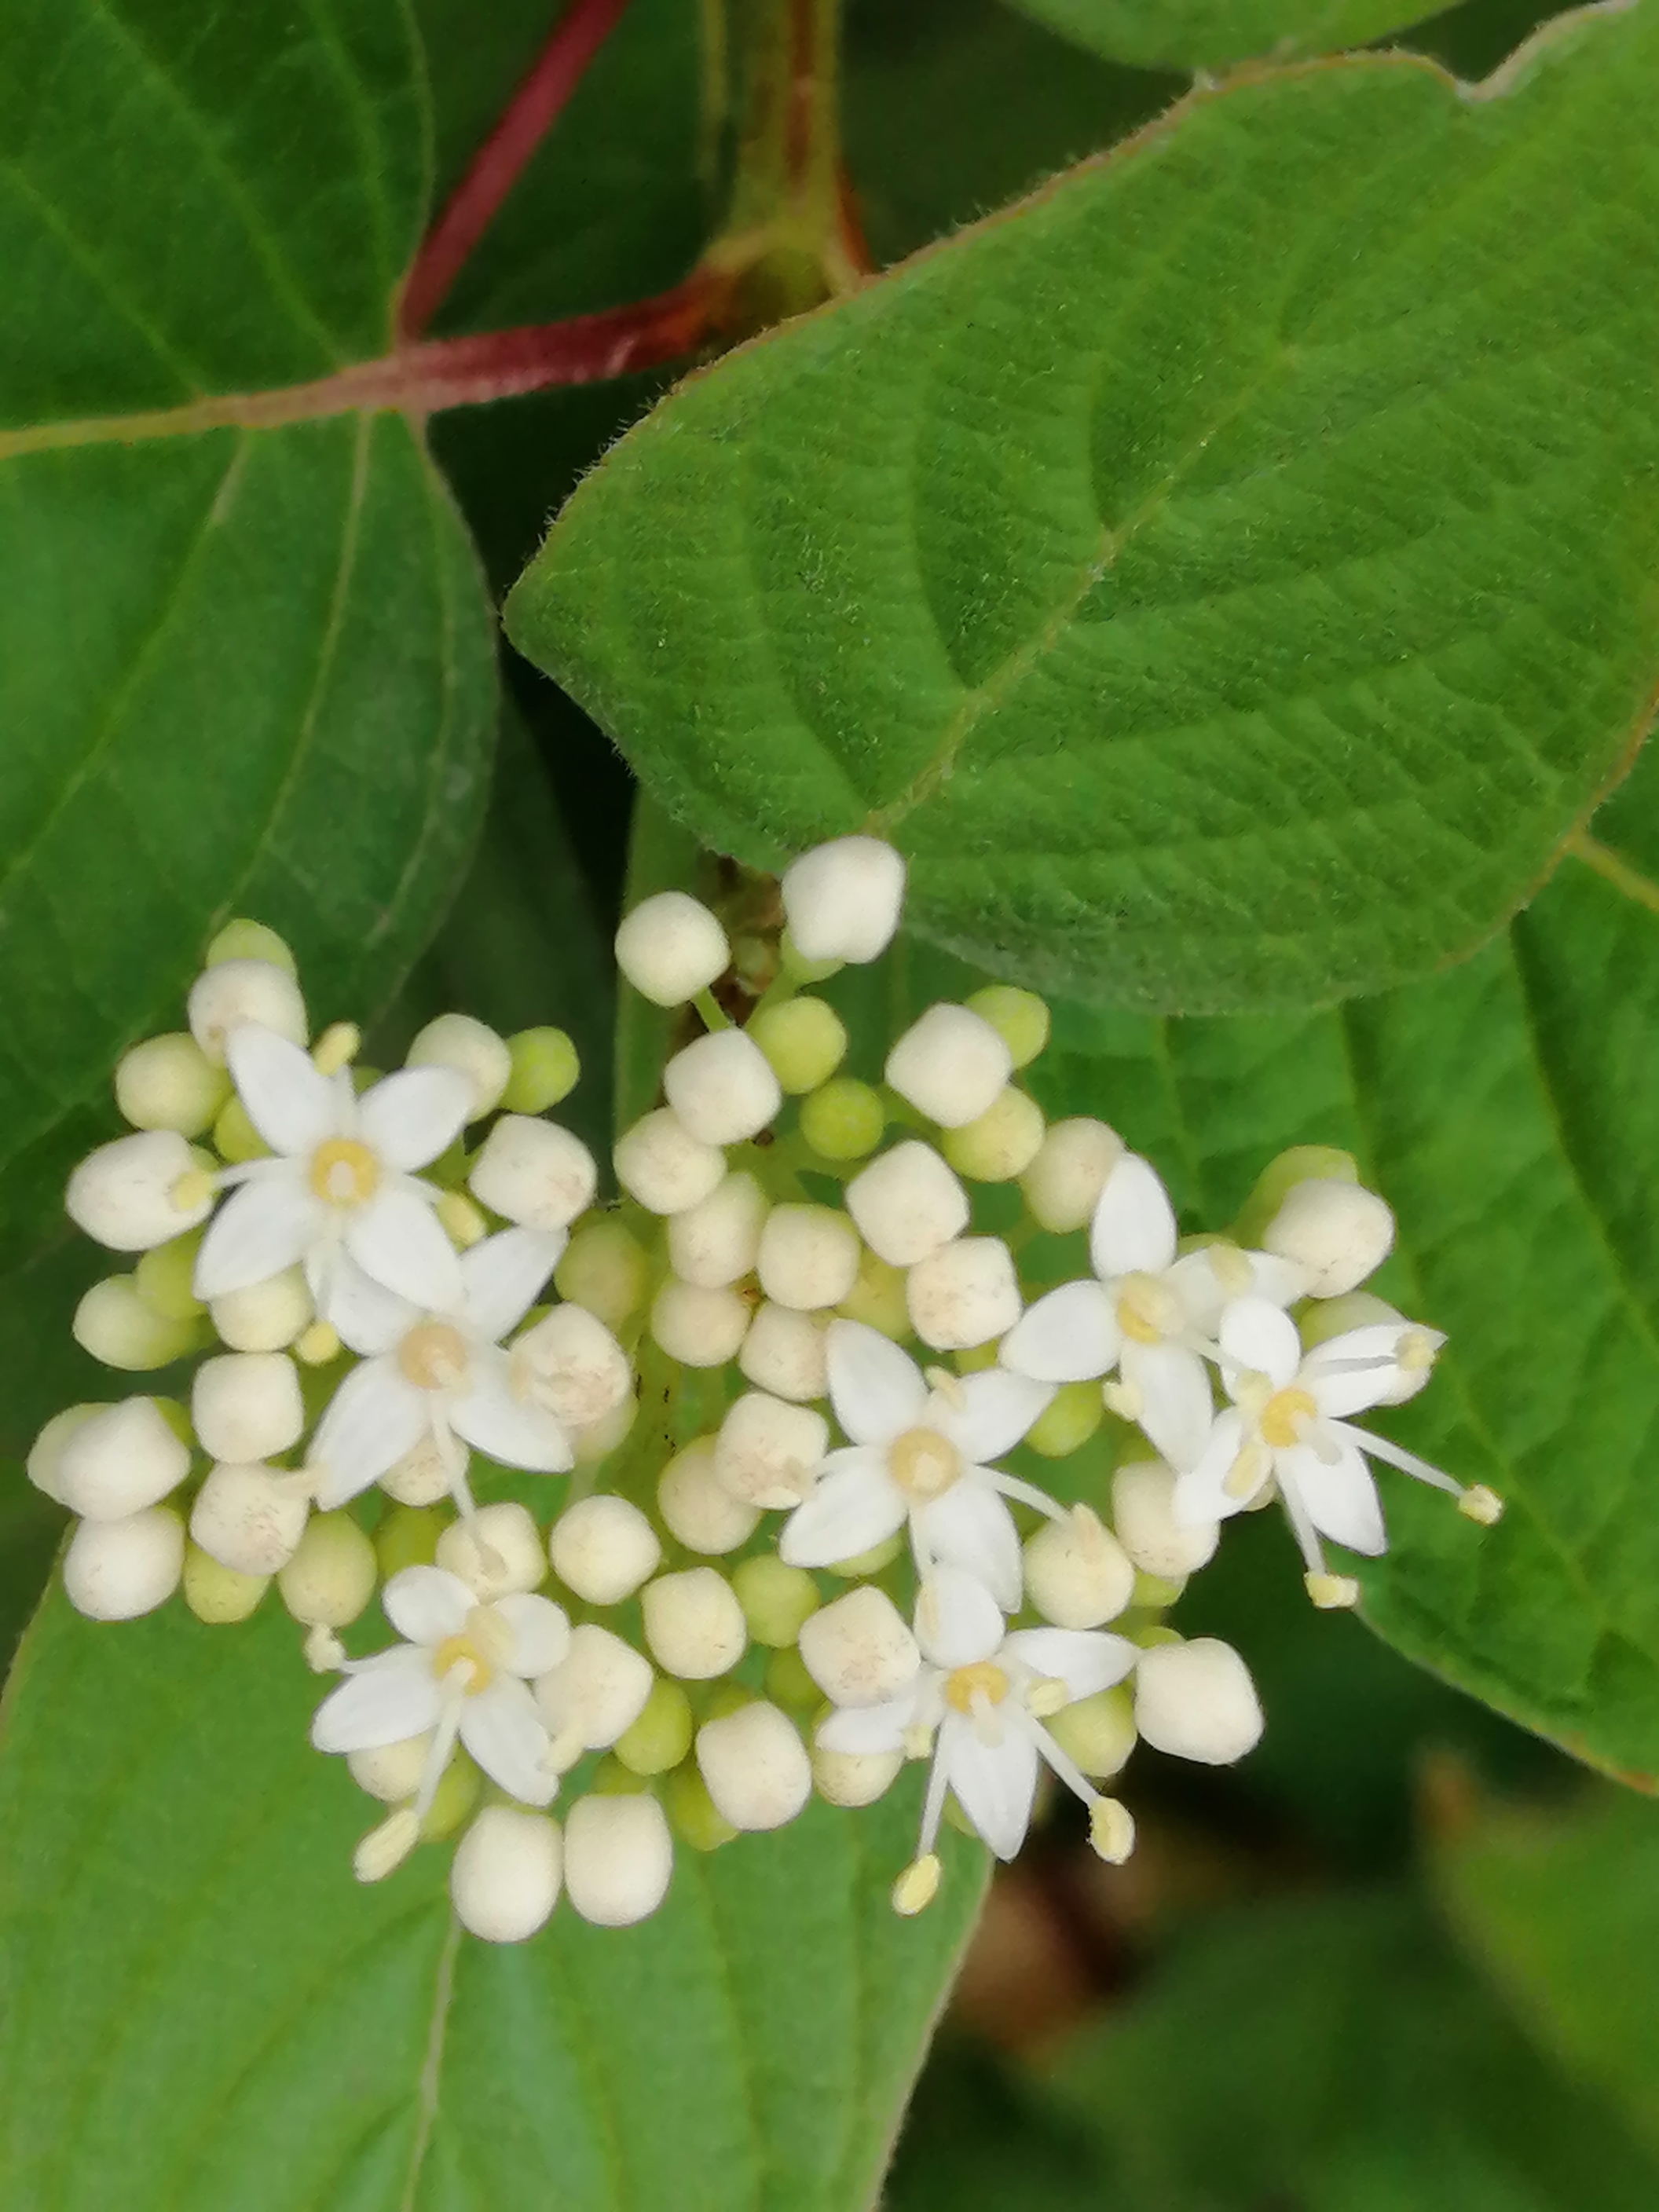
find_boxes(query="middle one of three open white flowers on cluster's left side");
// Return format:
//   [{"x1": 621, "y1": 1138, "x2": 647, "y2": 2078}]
[{"x1": 309, "y1": 1230, "x2": 573, "y2": 1511}]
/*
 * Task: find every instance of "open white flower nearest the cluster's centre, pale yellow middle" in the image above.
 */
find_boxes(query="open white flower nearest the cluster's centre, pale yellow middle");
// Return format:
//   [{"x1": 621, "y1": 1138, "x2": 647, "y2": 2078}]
[{"x1": 778, "y1": 1320, "x2": 1060, "y2": 1613}]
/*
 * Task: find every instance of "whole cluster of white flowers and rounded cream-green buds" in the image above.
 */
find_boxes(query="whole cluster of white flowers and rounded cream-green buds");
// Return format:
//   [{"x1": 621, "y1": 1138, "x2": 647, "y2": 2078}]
[{"x1": 29, "y1": 838, "x2": 1497, "y2": 1940}]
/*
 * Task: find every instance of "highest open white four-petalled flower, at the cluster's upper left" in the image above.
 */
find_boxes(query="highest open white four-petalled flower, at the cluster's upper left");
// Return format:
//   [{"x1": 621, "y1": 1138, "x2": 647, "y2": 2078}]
[{"x1": 195, "y1": 1022, "x2": 474, "y2": 1334}]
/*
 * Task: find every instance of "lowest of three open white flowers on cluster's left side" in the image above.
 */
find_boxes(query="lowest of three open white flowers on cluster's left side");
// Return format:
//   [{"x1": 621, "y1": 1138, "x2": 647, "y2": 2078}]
[{"x1": 312, "y1": 1566, "x2": 571, "y2": 1814}]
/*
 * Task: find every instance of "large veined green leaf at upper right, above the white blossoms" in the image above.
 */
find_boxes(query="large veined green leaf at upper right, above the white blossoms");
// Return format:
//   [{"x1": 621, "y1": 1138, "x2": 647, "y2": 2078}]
[{"x1": 507, "y1": 11, "x2": 1659, "y2": 1011}]
